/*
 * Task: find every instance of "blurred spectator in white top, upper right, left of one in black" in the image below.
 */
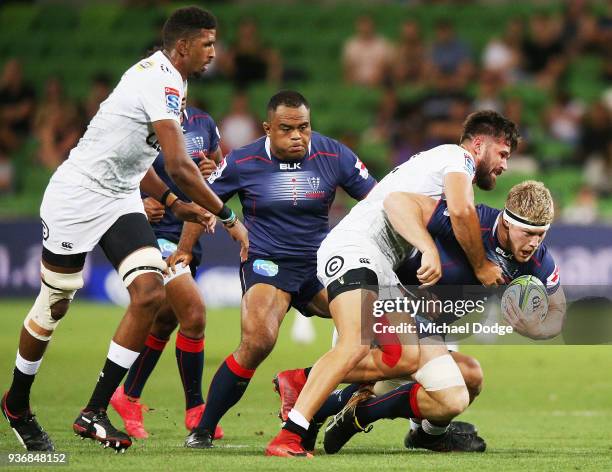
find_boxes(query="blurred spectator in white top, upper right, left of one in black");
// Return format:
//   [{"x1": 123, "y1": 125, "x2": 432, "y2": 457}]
[{"x1": 482, "y1": 18, "x2": 524, "y2": 83}]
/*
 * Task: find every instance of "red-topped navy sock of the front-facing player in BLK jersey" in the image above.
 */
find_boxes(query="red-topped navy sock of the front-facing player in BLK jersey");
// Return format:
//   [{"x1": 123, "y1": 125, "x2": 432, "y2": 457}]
[{"x1": 198, "y1": 354, "x2": 255, "y2": 432}]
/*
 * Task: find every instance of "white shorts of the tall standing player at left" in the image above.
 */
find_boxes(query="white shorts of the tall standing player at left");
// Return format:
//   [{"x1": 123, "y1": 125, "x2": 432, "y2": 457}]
[{"x1": 40, "y1": 176, "x2": 145, "y2": 255}]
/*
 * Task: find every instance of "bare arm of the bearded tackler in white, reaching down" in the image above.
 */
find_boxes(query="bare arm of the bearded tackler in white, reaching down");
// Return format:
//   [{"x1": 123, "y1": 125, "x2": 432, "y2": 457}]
[{"x1": 444, "y1": 172, "x2": 504, "y2": 286}]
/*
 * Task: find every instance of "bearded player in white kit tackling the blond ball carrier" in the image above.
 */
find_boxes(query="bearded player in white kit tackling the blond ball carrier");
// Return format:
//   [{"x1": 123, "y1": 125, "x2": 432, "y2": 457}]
[{"x1": 266, "y1": 111, "x2": 518, "y2": 457}]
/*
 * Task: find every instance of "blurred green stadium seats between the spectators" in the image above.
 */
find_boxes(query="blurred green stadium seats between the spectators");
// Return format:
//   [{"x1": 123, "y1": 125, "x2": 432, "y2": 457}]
[{"x1": 0, "y1": 1, "x2": 612, "y2": 219}]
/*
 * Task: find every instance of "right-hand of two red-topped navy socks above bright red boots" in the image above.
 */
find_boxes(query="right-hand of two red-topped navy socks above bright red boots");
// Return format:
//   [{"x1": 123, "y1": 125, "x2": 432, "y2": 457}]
[{"x1": 176, "y1": 331, "x2": 204, "y2": 410}]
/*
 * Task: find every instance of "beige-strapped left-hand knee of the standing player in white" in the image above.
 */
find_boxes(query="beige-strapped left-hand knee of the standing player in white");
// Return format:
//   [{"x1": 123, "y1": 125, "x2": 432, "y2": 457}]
[{"x1": 23, "y1": 265, "x2": 83, "y2": 341}]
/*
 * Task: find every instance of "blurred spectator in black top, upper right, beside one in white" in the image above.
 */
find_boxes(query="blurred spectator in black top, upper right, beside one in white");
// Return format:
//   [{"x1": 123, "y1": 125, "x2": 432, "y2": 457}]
[{"x1": 522, "y1": 13, "x2": 567, "y2": 89}]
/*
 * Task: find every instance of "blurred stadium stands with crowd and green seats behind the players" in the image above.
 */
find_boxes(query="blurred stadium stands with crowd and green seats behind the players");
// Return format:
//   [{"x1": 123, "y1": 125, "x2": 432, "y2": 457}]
[{"x1": 0, "y1": 0, "x2": 612, "y2": 305}]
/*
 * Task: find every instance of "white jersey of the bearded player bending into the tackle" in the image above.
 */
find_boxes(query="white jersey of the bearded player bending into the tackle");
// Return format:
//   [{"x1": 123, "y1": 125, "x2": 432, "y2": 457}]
[{"x1": 330, "y1": 144, "x2": 476, "y2": 268}]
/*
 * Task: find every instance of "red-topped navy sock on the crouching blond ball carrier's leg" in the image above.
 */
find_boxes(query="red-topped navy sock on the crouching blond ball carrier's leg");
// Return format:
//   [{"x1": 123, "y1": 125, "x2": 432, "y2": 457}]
[{"x1": 355, "y1": 382, "x2": 421, "y2": 427}]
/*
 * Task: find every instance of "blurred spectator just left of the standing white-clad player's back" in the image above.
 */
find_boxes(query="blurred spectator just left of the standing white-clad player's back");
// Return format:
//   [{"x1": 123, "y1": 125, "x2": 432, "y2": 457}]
[{"x1": 34, "y1": 78, "x2": 83, "y2": 169}]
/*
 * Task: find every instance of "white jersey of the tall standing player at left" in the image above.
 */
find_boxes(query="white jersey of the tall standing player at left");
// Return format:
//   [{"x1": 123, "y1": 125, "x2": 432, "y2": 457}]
[{"x1": 54, "y1": 51, "x2": 187, "y2": 198}]
